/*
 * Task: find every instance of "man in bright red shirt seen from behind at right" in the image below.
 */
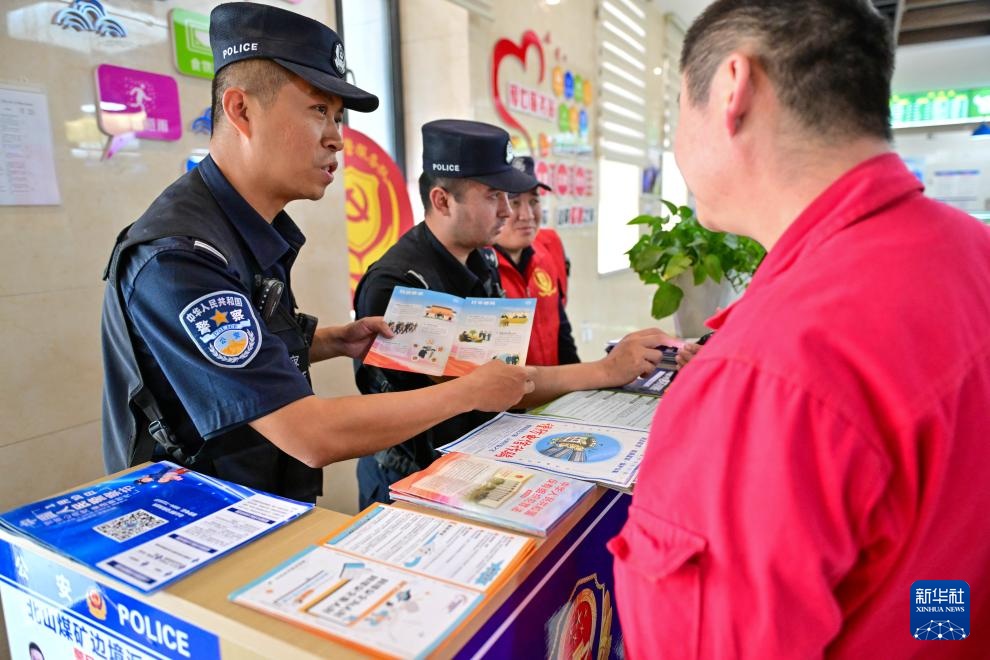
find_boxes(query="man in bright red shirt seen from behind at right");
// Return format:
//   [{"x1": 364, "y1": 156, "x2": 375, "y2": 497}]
[{"x1": 609, "y1": 0, "x2": 990, "y2": 658}]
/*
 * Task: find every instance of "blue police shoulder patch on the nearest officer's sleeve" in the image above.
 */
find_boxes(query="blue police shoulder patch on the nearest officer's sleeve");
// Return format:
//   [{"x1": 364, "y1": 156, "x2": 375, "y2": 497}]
[{"x1": 179, "y1": 291, "x2": 261, "y2": 369}]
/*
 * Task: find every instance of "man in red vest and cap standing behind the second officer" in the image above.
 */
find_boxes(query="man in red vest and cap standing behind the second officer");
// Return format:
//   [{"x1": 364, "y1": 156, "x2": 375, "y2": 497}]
[{"x1": 493, "y1": 156, "x2": 581, "y2": 366}]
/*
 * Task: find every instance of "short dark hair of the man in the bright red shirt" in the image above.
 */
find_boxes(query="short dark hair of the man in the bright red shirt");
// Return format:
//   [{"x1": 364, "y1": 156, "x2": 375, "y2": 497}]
[{"x1": 681, "y1": 0, "x2": 894, "y2": 140}]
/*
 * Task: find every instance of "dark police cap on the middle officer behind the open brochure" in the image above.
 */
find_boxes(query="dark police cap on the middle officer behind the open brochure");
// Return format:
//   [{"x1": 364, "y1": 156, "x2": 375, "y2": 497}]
[{"x1": 423, "y1": 119, "x2": 539, "y2": 193}]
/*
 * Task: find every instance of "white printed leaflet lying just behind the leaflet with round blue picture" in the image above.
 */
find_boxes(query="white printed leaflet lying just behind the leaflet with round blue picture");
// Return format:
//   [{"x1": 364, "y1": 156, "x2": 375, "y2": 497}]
[{"x1": 529, "y1": 390, "x2": 660, "y2": 431}]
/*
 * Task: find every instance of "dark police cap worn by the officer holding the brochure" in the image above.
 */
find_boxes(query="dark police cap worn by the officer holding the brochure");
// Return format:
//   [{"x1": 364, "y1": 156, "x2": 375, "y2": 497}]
[{"x1": 210, "y1": 2, "x2": 378, "y2": 112}]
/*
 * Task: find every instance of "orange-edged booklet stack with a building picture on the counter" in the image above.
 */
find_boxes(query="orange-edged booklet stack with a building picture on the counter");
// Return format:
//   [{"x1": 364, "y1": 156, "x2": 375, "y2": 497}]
[{"x1": 389, "y1": 452, "x2": 594, "y2": 536}]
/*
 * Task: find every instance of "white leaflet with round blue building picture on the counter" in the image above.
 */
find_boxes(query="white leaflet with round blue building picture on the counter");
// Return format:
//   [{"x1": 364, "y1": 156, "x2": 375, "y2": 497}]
[{"x1": 439, "y1": 413, "x2": 647, "y2": 490}]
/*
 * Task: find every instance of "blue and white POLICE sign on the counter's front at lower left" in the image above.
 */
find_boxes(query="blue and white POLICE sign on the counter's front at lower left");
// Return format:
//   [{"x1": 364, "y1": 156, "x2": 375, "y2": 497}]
[{"x1": 0, "y1": 538, "x2": 220, "y2": 660}]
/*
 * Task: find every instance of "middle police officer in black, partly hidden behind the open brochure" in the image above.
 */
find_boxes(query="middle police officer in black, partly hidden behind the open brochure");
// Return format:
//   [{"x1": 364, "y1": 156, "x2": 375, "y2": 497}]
[{"x1": 354, "y1": 119, "x2": 669, "y2": 508}]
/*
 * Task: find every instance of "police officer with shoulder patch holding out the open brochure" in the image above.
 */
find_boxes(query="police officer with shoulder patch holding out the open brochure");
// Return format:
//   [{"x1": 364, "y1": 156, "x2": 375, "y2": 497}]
[{"x1": 103, "y1": 3, "x2": 532, "y2": 501}]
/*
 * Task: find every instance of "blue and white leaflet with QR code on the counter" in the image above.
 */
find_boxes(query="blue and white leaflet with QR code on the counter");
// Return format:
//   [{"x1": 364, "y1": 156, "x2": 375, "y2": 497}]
[{"x1": 0, "y1": 462, "x2": 313, "y2": 592}]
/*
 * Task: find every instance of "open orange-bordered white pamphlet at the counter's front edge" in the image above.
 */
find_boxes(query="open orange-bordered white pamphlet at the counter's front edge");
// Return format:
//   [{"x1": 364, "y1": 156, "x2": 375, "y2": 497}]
[{"x1": 230, "y1": 504, "x2": 535, "y2": 657}]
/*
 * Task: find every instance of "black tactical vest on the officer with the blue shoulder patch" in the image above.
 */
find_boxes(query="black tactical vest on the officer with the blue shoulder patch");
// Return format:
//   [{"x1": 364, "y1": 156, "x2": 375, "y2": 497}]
[{"x1": 102, "y1": 170, "x2": 323, "y2": 502}]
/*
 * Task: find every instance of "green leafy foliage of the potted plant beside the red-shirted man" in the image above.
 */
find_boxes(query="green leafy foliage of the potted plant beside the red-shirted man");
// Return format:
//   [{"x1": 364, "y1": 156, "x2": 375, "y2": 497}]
[{"x1": 627, "y1": 200, "x2": 766, "y2": 335}]
